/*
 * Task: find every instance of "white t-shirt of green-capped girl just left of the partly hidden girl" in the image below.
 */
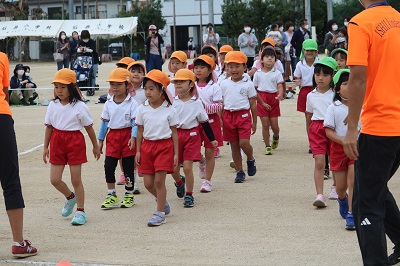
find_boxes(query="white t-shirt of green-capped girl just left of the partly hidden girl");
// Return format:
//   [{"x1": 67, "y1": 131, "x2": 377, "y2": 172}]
[{"x1": 306, "y1": 89, "x2": 335, "y2": 120}]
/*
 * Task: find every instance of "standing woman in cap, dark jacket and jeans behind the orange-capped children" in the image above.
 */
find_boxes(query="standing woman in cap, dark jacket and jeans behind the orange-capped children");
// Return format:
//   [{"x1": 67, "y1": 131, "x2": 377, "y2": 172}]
[{"x1": 146, "y1": 25, "x2": 164, "y2": 72}]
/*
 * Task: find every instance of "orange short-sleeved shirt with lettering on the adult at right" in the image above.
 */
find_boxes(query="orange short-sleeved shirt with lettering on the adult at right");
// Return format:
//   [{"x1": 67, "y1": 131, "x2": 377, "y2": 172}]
[{"x1": 347, "y1": 6, "x2": 400, "y2": 136}]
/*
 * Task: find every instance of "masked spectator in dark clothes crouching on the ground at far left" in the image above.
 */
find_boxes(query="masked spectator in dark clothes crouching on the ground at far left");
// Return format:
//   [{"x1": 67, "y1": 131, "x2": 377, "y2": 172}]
[{"x1": 10, "y1": 64, "x2": 38, "y2": 106}]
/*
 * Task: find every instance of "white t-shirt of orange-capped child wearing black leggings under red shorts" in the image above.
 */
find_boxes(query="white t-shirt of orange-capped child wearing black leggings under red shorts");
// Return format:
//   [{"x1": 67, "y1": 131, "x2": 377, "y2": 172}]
[{"x1": 101, "y1": 94, "x2": 138, "y2": 129}]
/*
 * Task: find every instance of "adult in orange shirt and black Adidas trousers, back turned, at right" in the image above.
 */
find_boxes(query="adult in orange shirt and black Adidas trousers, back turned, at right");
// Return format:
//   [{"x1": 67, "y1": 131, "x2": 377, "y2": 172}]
[{"x1": 344, "y1": 0, "x2": 400, "y2": 265}]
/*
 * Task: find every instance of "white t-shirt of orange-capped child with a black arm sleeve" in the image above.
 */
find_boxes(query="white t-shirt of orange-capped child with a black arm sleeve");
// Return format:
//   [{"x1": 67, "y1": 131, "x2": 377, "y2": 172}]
[{"x1": 173, "y1": 96, "x2": 208, "y2": 129}]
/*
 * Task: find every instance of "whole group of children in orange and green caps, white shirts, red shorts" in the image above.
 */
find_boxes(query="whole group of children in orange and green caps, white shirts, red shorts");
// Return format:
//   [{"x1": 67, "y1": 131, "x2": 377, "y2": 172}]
[{"x1": 43, "y1": 38, "x2": 352, "y2": 231}]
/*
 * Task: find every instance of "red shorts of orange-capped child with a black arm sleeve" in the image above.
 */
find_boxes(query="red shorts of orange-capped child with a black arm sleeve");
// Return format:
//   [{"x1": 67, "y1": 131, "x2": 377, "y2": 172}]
[{"x1": 178, "y1": 127, "x2": 201, "y2": 163}]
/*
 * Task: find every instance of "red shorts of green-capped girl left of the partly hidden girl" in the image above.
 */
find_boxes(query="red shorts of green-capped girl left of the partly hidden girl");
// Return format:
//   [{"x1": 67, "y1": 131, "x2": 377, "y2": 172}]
[{"x1": 308, "y1": 120, "x2": 331, "y2": 155}]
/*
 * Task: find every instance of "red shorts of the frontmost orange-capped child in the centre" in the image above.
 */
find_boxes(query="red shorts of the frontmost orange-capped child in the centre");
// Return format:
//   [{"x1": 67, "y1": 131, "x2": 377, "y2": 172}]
[{"x1": 138, "y1": 138, "x2": 174, "y2": 175}]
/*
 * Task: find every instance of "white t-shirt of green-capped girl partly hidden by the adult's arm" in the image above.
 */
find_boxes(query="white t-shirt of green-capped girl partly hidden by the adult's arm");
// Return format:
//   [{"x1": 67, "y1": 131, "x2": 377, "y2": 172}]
[{"x1": 324, "y1": 101, "x2": 361, "y2": 138}]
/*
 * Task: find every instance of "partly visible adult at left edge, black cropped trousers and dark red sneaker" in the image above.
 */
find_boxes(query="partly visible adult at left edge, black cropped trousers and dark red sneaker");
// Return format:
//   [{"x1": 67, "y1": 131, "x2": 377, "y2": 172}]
[{"x1": 0, "y1": 52, "x2": 37, "y2": 258}]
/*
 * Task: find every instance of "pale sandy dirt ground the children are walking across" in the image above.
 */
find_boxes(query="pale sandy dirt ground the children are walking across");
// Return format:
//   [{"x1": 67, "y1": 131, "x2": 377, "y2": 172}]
[{"x1": 0, "y1": 62, "x2": 400, "y2": 265}]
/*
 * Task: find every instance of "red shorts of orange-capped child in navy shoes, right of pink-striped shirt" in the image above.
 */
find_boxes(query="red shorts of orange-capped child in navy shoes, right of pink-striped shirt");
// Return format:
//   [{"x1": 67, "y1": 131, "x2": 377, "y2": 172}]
[{"x1": 222, "y1": 109, "x2": 253, "y2": 142}]
